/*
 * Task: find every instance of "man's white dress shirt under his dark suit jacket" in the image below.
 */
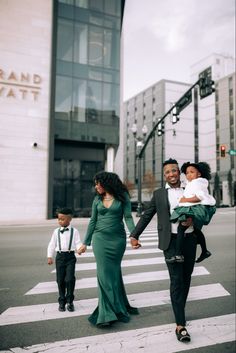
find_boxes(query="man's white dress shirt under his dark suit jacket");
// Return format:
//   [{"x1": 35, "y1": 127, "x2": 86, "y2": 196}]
[{"x1": 166, "y1": 183, "x2": 193, "y2": 234}]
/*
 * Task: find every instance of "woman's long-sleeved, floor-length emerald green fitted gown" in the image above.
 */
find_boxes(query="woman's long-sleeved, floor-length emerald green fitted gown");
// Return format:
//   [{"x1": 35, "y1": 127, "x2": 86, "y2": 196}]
[{"x1": 83, "y1": 193, "x2": 138, "y2": 325}]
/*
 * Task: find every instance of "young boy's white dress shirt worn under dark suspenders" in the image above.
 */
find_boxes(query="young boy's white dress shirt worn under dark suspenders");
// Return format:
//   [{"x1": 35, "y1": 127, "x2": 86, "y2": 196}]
[{"x1": 47, "y1": 225, "x2": 82, "y2": 257}]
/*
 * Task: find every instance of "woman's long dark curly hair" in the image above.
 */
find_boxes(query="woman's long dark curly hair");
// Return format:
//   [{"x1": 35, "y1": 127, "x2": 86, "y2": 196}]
[{"x1": 93, "y1": 171, "x2": 129, "y2": 202}]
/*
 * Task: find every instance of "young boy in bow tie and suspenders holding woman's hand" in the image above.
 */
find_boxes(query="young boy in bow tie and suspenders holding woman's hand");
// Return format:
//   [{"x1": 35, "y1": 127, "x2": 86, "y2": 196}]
[{"x1": 47, "y1": 208, "x2": 82, "y2": 311}]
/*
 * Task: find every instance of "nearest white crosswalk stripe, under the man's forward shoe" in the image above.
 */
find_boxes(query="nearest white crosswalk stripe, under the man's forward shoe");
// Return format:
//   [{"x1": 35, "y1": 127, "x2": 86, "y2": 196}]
[{"x1": 1, "y1": 314, "x2": 236, "y2": 353}]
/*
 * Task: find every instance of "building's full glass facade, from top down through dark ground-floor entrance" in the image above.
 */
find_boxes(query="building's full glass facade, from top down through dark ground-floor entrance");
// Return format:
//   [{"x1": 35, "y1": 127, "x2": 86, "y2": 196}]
[{"x1": 52, "y1": 0, "x2": 124, "y2": 216}]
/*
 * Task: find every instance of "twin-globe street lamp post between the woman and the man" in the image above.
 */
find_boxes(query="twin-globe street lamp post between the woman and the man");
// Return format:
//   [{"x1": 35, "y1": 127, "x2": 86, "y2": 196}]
[{"x1": 131, "y1": 124, "x2": 148, "y2": 217}]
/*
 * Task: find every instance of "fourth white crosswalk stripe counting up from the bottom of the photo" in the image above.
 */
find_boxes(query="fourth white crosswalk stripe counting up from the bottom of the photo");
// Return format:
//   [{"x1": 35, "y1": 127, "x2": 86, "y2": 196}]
[{"x1": 51, "y1": 257, "x2": 165, "y2": 273}]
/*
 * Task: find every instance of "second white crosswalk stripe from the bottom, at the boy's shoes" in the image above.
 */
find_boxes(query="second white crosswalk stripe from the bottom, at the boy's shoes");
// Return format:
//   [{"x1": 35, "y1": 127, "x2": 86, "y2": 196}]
[{"x1": 0, "y1": 283, "x2": 230, "y2": 326}]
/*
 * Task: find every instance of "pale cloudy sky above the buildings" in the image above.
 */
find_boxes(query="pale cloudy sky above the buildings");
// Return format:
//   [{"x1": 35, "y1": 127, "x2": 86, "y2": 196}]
[{"x1": 123, "y1": 0, "x2": 235, "y2": 101}]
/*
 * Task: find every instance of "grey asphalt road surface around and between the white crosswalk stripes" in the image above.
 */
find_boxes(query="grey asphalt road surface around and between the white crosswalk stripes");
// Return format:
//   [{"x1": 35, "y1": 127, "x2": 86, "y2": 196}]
[{"x1": 0, "y1": 208, "x2": 235, "y2": 353}]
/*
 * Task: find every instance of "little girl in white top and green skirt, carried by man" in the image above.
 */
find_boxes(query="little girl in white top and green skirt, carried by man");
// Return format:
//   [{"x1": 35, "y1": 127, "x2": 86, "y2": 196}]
[{"x1": 166, "y1": 162, "x2": 216, "y2": 263}]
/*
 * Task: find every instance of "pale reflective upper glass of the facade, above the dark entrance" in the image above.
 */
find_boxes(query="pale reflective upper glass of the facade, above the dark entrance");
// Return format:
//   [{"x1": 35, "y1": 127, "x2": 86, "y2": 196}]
[{"x1": 55, "y1": 0, "x2": 121, "y2": 133}]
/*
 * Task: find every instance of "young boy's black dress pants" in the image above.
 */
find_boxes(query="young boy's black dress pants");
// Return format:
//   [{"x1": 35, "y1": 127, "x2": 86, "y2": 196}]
[{"x1": 56, "y1": 251, "x2": 76, "y2": 305}]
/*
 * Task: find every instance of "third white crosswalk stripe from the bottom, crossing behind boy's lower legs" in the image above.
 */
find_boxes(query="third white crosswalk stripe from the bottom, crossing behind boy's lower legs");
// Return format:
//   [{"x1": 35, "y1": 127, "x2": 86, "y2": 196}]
[{"x1": 25, "y1": 266, "x2": 209, "y2": 295}]
